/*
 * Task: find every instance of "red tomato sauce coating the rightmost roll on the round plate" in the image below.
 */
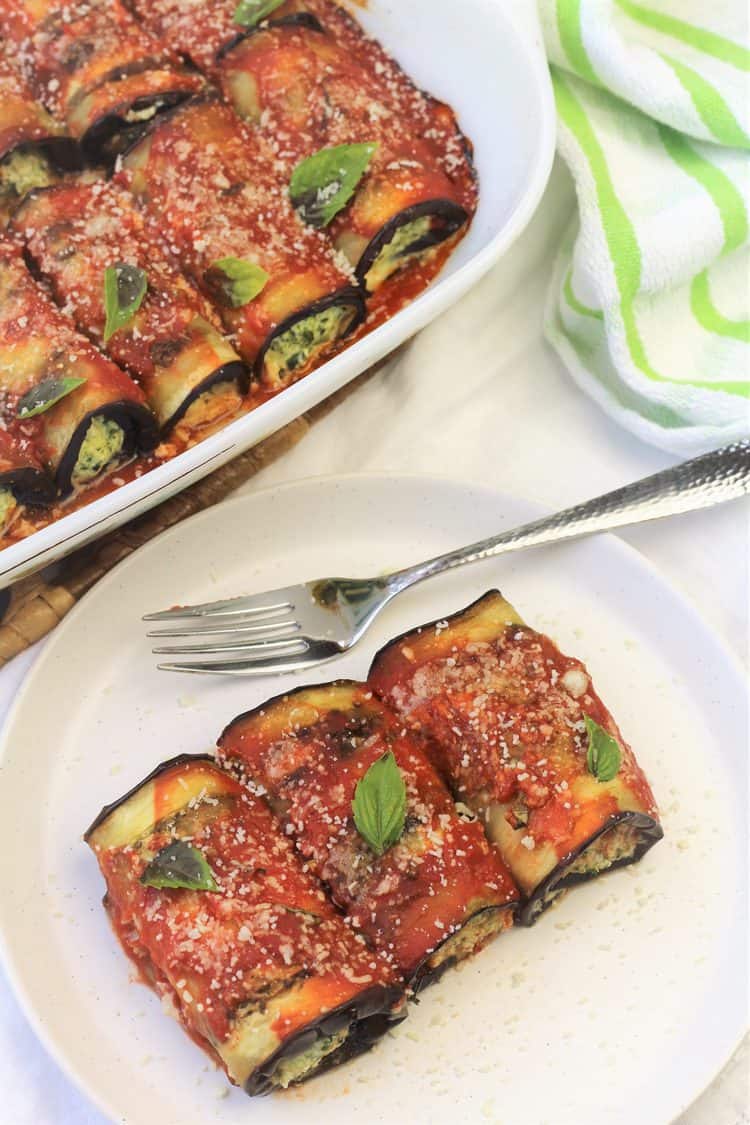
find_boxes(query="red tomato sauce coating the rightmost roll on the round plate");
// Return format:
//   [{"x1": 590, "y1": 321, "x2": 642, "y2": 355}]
[{"x1": 369, "y1": 595, "x2": 657, "y2": 857}]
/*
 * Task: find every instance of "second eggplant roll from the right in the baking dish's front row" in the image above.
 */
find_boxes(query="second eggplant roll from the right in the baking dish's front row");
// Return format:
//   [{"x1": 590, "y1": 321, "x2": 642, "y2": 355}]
[{"x1": 121, "y1": 98, "x2": 364, "y2": 392}]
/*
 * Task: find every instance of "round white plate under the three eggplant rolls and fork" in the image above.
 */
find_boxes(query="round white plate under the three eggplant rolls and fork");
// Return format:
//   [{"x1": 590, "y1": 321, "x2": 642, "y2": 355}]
[{"x1": 0, "y1": 477, "x2": 747, "y2": 1125}]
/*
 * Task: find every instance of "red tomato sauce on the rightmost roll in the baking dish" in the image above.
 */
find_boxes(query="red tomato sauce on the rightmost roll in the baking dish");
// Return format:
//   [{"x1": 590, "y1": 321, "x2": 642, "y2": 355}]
[{"x1": 217, "y1": 15, "x2": 477, "y2": 217}]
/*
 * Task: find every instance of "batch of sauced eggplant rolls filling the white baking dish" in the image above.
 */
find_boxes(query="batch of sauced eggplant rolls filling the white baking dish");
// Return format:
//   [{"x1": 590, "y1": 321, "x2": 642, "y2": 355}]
[{"x1": 0, "y1": 0, "x2": 477, "y2": 535}]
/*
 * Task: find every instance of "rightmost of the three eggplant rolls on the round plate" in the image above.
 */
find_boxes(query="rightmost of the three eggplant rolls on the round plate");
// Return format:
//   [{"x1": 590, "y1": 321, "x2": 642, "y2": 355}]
[{"x1": 369, "y1": 591, "x2": 662, "y2": 924}]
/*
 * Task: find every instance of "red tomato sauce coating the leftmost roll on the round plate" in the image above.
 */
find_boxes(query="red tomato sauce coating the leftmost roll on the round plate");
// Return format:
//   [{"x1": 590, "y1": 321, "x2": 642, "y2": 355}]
[{"x1": 90, "y1": 763, "x2": 391, "y2": 1062}]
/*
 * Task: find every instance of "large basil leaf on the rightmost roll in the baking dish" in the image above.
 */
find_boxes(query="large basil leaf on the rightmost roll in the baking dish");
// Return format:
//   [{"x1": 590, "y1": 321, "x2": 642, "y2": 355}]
[{"x1": 289, "y1": 143, "x2": 378, "y2": 227}]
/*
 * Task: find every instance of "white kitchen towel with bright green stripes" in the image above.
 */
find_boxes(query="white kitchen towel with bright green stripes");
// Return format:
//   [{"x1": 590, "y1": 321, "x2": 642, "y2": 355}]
[{"x1": 540, "y1": 0, "x2": 750, "y2": 453}]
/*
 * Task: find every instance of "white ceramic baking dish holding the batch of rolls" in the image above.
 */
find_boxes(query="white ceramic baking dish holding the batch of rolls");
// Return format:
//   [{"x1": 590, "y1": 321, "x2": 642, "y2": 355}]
[{"x1": 0, "y1": 0, "x2": 554, "y2": 588}]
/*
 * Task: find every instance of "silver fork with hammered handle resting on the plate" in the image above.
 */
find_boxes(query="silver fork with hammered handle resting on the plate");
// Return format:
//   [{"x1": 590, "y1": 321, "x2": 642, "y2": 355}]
[{"x1": 143, "y1": 441, "x2": 750, "y2": 676}]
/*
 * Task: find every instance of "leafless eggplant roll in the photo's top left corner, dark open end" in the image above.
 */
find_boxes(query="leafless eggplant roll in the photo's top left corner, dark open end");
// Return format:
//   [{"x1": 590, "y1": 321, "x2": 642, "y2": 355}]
[{"x1": 0, "y1": 0, "x2": 204, "y2": 164}]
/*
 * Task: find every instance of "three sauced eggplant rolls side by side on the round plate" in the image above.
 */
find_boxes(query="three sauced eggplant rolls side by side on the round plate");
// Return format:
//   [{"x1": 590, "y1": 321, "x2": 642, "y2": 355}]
[{"x1": 85, "y1": 592, "x2": 662, "y2": 1094}]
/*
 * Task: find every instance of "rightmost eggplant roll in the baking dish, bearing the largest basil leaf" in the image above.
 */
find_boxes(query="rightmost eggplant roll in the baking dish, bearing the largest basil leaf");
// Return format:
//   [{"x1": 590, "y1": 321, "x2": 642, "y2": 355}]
[{"x1": 123, "y1": 0, "x2": 477, "y2": 291}]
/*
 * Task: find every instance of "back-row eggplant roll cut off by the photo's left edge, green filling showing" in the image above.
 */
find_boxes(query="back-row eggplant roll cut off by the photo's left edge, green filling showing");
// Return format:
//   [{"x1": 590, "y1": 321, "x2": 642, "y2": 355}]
[{"x1": 0, "y1": 50, "x2": 80, "y2": 226}]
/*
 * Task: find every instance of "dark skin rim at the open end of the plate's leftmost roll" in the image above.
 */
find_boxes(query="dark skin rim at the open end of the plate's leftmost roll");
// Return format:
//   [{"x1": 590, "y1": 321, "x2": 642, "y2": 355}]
[{"x1": 244, "y1": 984, "x2": 406, "y2": 1097}]
